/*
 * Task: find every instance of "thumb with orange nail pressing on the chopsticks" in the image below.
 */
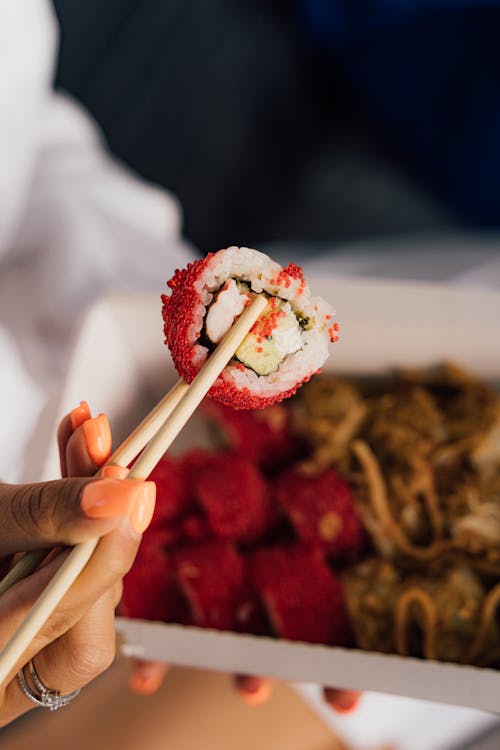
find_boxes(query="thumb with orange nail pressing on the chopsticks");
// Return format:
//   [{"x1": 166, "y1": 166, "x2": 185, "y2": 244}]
[{"x1": 0, "y1": 478, "x2": 154, "y2": 557}]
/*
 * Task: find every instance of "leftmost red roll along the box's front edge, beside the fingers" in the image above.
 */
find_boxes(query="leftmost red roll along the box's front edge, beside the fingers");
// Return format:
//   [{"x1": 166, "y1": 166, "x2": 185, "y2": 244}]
[{"x1": 120, "y1": 529, "x2": 189, "y2": 623}]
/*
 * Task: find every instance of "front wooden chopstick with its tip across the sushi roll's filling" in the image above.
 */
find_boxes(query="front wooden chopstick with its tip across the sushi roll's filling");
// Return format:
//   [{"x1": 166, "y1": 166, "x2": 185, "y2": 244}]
[{"x1": 0, "y1": 296, "x2": 267, "y2": 684}]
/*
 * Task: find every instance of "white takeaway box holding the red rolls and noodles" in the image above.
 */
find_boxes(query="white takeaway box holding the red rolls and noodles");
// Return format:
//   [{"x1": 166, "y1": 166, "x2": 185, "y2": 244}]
[{"x1": 41, "y1": 278, "x2": 500, "y2": 748}]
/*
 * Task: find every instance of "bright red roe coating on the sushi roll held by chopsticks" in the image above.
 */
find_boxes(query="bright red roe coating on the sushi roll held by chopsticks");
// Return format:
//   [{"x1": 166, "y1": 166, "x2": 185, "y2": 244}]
[{"x1": 162, "y1": 253, "x2": 328, "y2": 409}]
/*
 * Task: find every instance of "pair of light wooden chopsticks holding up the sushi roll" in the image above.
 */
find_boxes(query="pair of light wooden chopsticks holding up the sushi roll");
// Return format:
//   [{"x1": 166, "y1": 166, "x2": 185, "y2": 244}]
[{"x1": 0, "y1": 295, "x2": 267, "y2": 684}]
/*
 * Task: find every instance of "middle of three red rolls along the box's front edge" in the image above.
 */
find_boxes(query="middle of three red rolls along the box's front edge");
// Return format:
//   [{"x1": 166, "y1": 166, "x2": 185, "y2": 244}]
[{"x1": 173, "y1": 540, "x2": 253, "y2": 630}]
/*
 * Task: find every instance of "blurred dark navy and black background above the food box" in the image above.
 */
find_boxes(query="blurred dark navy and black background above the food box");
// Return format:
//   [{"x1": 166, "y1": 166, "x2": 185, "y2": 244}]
[{"x1": 50, "y1": 0, "x2": 500, "y2": 251}]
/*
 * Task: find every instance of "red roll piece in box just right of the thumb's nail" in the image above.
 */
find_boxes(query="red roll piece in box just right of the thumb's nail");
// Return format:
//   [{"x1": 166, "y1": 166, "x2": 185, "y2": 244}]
[{"x1": 149, "y1": 456, "x2": 193, "y2": 527}]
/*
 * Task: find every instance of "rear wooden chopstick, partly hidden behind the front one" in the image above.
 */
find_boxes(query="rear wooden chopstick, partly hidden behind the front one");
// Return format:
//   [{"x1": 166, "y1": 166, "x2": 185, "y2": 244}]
[{"x1": 0, "y1": 378, "x2": 189, "y2": 596}]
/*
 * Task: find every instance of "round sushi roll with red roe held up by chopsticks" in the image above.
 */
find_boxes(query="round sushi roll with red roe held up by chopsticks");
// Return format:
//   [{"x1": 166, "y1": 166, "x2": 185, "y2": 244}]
[{"x1": 162, "y1": 247, "x2": 338, "y2": 409}]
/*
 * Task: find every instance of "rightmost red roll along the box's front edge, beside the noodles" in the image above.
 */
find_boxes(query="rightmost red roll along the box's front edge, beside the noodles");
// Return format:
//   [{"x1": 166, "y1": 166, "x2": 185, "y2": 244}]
[{"x1": 250, "y1": 545, "x2": 351, "y2": 646}]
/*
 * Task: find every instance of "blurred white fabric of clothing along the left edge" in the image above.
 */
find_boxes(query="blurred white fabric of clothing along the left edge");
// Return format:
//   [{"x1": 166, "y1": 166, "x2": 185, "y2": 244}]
[{"x1": 0, "y1": 0, "x2": 191, "y2": 480}]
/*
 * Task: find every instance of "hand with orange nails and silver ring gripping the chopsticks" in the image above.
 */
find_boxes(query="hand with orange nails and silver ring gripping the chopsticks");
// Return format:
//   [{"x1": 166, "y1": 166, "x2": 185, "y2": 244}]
[{"x1": 0, "y1": 410, "x2": 155, "y2": 726}]
